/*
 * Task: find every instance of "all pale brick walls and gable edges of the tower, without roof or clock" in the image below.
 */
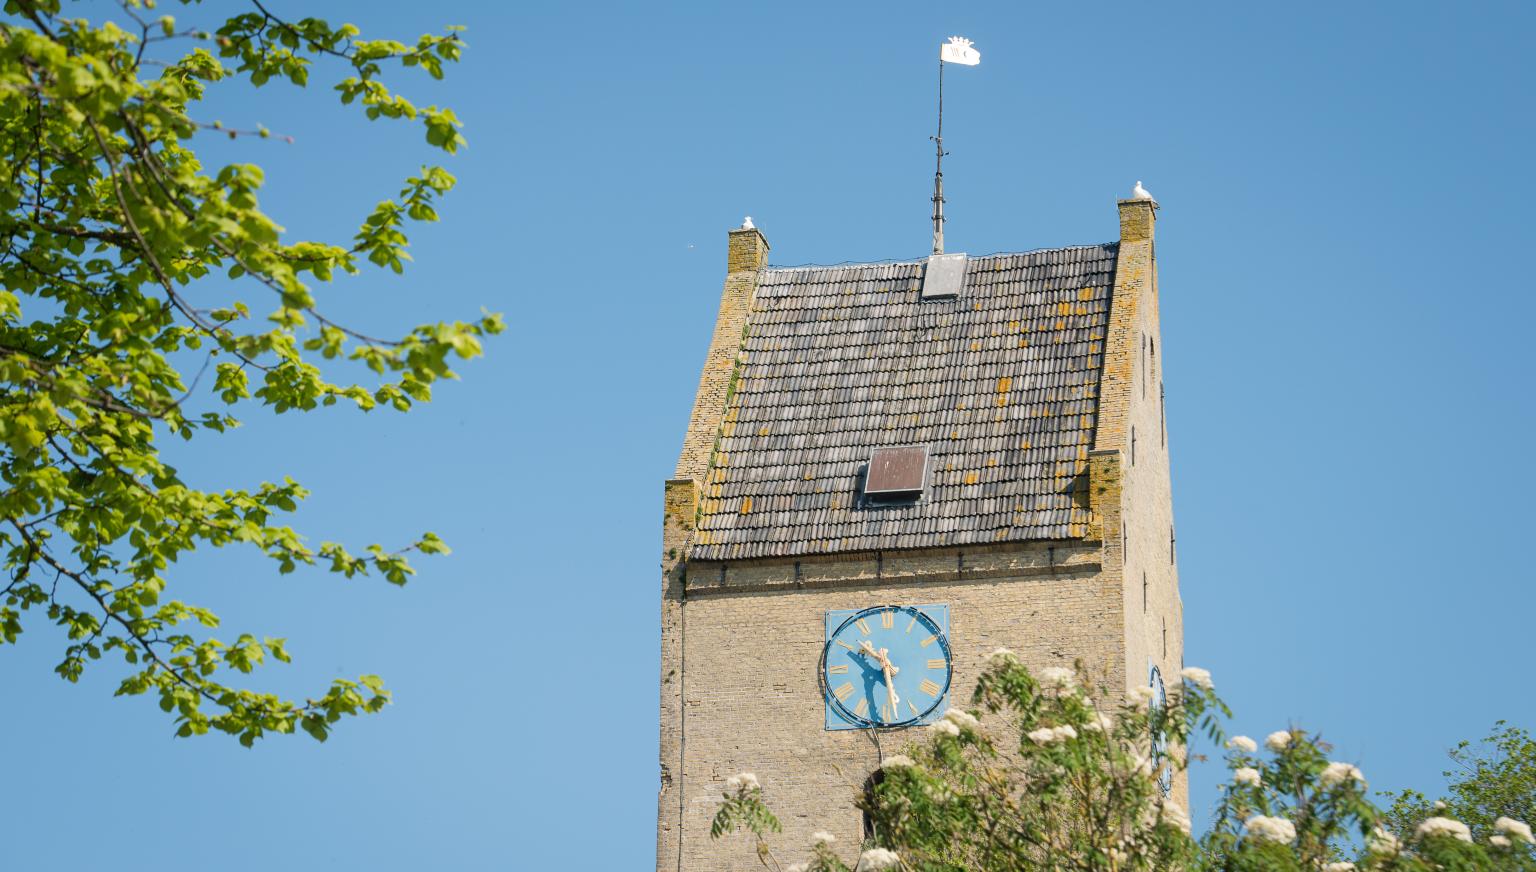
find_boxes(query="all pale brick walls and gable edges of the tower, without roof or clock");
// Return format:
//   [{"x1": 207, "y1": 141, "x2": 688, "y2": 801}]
[{"x1": 657, "y1": 201, "x2": 1187, "y2": 872}]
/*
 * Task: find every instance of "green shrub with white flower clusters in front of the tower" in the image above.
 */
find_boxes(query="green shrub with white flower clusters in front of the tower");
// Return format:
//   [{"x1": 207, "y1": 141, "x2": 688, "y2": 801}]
[{"x1": 711, "y1": 649, "x2": 1536, "y2": 872}]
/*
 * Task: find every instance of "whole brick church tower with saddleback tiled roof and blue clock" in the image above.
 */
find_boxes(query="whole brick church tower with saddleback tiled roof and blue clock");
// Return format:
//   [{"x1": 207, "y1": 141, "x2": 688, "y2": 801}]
[{"x1": 656, "y1": 194, "x2": 1184, "y2": 872}]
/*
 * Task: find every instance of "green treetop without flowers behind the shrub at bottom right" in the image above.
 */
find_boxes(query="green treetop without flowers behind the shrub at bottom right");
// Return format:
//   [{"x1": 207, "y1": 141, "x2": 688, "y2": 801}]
[{"x1": 1387, "y1": 720, "x2": 1536, "y2": 838}]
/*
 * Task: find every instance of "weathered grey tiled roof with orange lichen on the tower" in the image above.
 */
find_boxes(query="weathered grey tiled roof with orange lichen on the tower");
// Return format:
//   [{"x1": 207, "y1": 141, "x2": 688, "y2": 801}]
[{"x1": 690, "y1": 244, "x2": 1117, "y2": 560}]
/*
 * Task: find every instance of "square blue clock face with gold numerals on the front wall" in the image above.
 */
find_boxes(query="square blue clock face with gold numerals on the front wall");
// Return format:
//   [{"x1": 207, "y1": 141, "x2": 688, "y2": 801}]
[{"x1": 822, "y1": 605, "x2": 952, "y2": 729}]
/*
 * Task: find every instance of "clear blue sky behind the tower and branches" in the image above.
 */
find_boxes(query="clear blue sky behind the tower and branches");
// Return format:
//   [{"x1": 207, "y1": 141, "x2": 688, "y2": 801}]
[{"x1": 0, "y1": 0, "x2": 1536, "y2": 872}]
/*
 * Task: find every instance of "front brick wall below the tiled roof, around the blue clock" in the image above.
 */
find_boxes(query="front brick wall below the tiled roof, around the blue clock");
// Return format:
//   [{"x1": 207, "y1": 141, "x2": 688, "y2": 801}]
[{"x1": 667, "y1": 543, "x2": 1126, "y2": 870}]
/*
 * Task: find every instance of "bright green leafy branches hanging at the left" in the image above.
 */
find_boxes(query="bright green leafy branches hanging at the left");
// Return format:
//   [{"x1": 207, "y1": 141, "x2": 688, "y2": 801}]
[{"x1": 0, "y1": 0, "x2": 502, "y2": 745}]
